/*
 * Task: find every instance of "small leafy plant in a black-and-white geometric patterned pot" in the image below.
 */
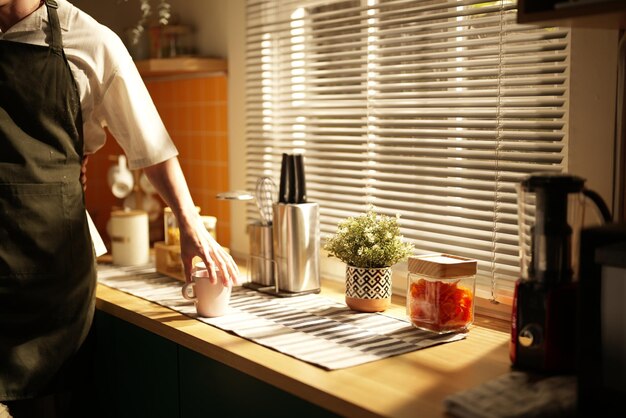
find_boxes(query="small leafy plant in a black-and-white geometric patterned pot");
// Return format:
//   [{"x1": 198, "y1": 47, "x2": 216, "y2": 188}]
[{"x1": 324, "y1": 210, "x2": 413, "y2": 312}]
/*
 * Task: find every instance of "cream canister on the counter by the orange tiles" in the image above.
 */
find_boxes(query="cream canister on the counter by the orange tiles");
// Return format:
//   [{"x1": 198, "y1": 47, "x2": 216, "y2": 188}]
[{"x1": 107, "y1": 210, "x2": 150, "y2": 266}]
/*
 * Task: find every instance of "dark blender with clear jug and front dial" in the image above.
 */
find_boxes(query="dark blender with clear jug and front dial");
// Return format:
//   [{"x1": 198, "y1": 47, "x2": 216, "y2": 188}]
[{"x1": 509, "y1": 173, "x2": 608, "y2": 373}]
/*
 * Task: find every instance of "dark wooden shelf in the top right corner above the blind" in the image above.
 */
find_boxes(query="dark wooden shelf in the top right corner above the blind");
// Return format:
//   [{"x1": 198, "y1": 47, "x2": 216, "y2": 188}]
[{"x1": 517, "y1": 0, "x2": 626, "y2": 29}]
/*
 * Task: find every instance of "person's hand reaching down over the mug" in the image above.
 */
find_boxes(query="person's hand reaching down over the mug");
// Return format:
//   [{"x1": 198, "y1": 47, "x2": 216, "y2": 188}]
[{"x1": 179, "y1": 214, "x2": 239, "y2": 286}]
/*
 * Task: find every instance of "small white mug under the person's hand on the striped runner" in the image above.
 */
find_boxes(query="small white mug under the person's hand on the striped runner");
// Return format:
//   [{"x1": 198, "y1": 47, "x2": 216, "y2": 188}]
[{"x1": 182, "y1": 269, "x2": 231, "y2": 318}]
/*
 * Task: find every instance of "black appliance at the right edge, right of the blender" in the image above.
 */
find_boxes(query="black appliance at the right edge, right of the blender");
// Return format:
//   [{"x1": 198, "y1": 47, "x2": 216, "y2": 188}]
[{"x1": 577, "y1": 223, "x2": 626, "y2": 417}]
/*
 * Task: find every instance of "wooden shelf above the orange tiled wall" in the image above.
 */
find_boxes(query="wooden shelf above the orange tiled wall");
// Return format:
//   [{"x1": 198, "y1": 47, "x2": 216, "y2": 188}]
[{"x1": 135, "y1": 57, "x2": 228, "y2": 77}]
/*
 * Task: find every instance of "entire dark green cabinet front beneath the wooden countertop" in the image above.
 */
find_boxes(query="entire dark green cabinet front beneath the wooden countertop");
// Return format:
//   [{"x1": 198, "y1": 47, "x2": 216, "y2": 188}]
[{"x1": 94, "y1": 311, "x2": 337, "y2": 418}]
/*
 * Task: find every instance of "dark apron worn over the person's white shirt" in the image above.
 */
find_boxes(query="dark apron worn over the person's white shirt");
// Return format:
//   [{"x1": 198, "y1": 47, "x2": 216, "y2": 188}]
[{"x1": 0, "y1": 0, "x2": 96, "y2": 401}]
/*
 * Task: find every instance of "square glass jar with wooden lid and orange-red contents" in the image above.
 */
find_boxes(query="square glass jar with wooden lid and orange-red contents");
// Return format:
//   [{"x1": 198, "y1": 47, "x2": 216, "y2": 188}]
[{"x1": 406, "y1": 254, "x2": 476, "y2": 334}]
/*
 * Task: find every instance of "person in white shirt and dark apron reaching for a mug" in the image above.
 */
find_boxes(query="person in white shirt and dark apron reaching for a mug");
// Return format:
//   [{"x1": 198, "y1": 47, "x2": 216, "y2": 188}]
[{"x1": 0, "y1": 0, "x2": 239, "y2": 418}]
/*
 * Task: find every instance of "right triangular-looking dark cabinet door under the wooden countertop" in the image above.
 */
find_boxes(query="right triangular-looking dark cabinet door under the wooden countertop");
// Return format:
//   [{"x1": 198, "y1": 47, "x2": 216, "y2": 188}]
[{"x1": 179, "y1": 347, "x2": 337, "y2": 418}]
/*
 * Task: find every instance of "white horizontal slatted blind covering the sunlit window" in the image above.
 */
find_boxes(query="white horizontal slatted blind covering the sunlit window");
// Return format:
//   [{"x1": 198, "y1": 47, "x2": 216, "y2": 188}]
[{"x1": 246, "y1": 0, "x2": 569, "y2": 298}]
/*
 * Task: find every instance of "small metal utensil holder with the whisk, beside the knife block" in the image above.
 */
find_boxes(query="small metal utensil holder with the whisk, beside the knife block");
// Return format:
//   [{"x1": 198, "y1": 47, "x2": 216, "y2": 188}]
[{"x1": 243, "y1": 222, "x2": 276, "y2": 290}]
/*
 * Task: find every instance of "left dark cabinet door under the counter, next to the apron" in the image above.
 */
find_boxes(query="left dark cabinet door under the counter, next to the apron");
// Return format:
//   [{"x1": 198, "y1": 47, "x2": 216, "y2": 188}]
[{"x1": 94, "y1": 311, "x2": 179, "y2": 418}]
